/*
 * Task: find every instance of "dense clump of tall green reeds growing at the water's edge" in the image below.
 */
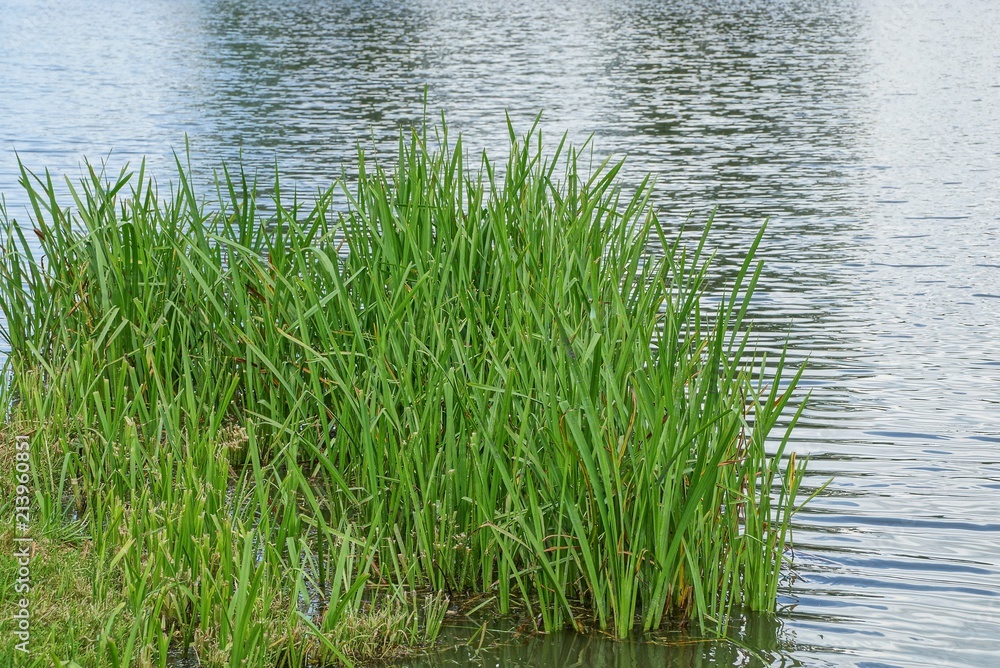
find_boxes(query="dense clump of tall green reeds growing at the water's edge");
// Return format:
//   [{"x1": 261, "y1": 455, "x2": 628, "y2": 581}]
[{"x1": 0, "y1": 121, "x2": 801, "y2": 666}]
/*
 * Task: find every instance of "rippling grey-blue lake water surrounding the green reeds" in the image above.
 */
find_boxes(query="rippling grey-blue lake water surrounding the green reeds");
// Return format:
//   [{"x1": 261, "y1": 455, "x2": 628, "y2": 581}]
[{"x1": 0, "y1": 0, "x2": 1000, "y2": 668}]
